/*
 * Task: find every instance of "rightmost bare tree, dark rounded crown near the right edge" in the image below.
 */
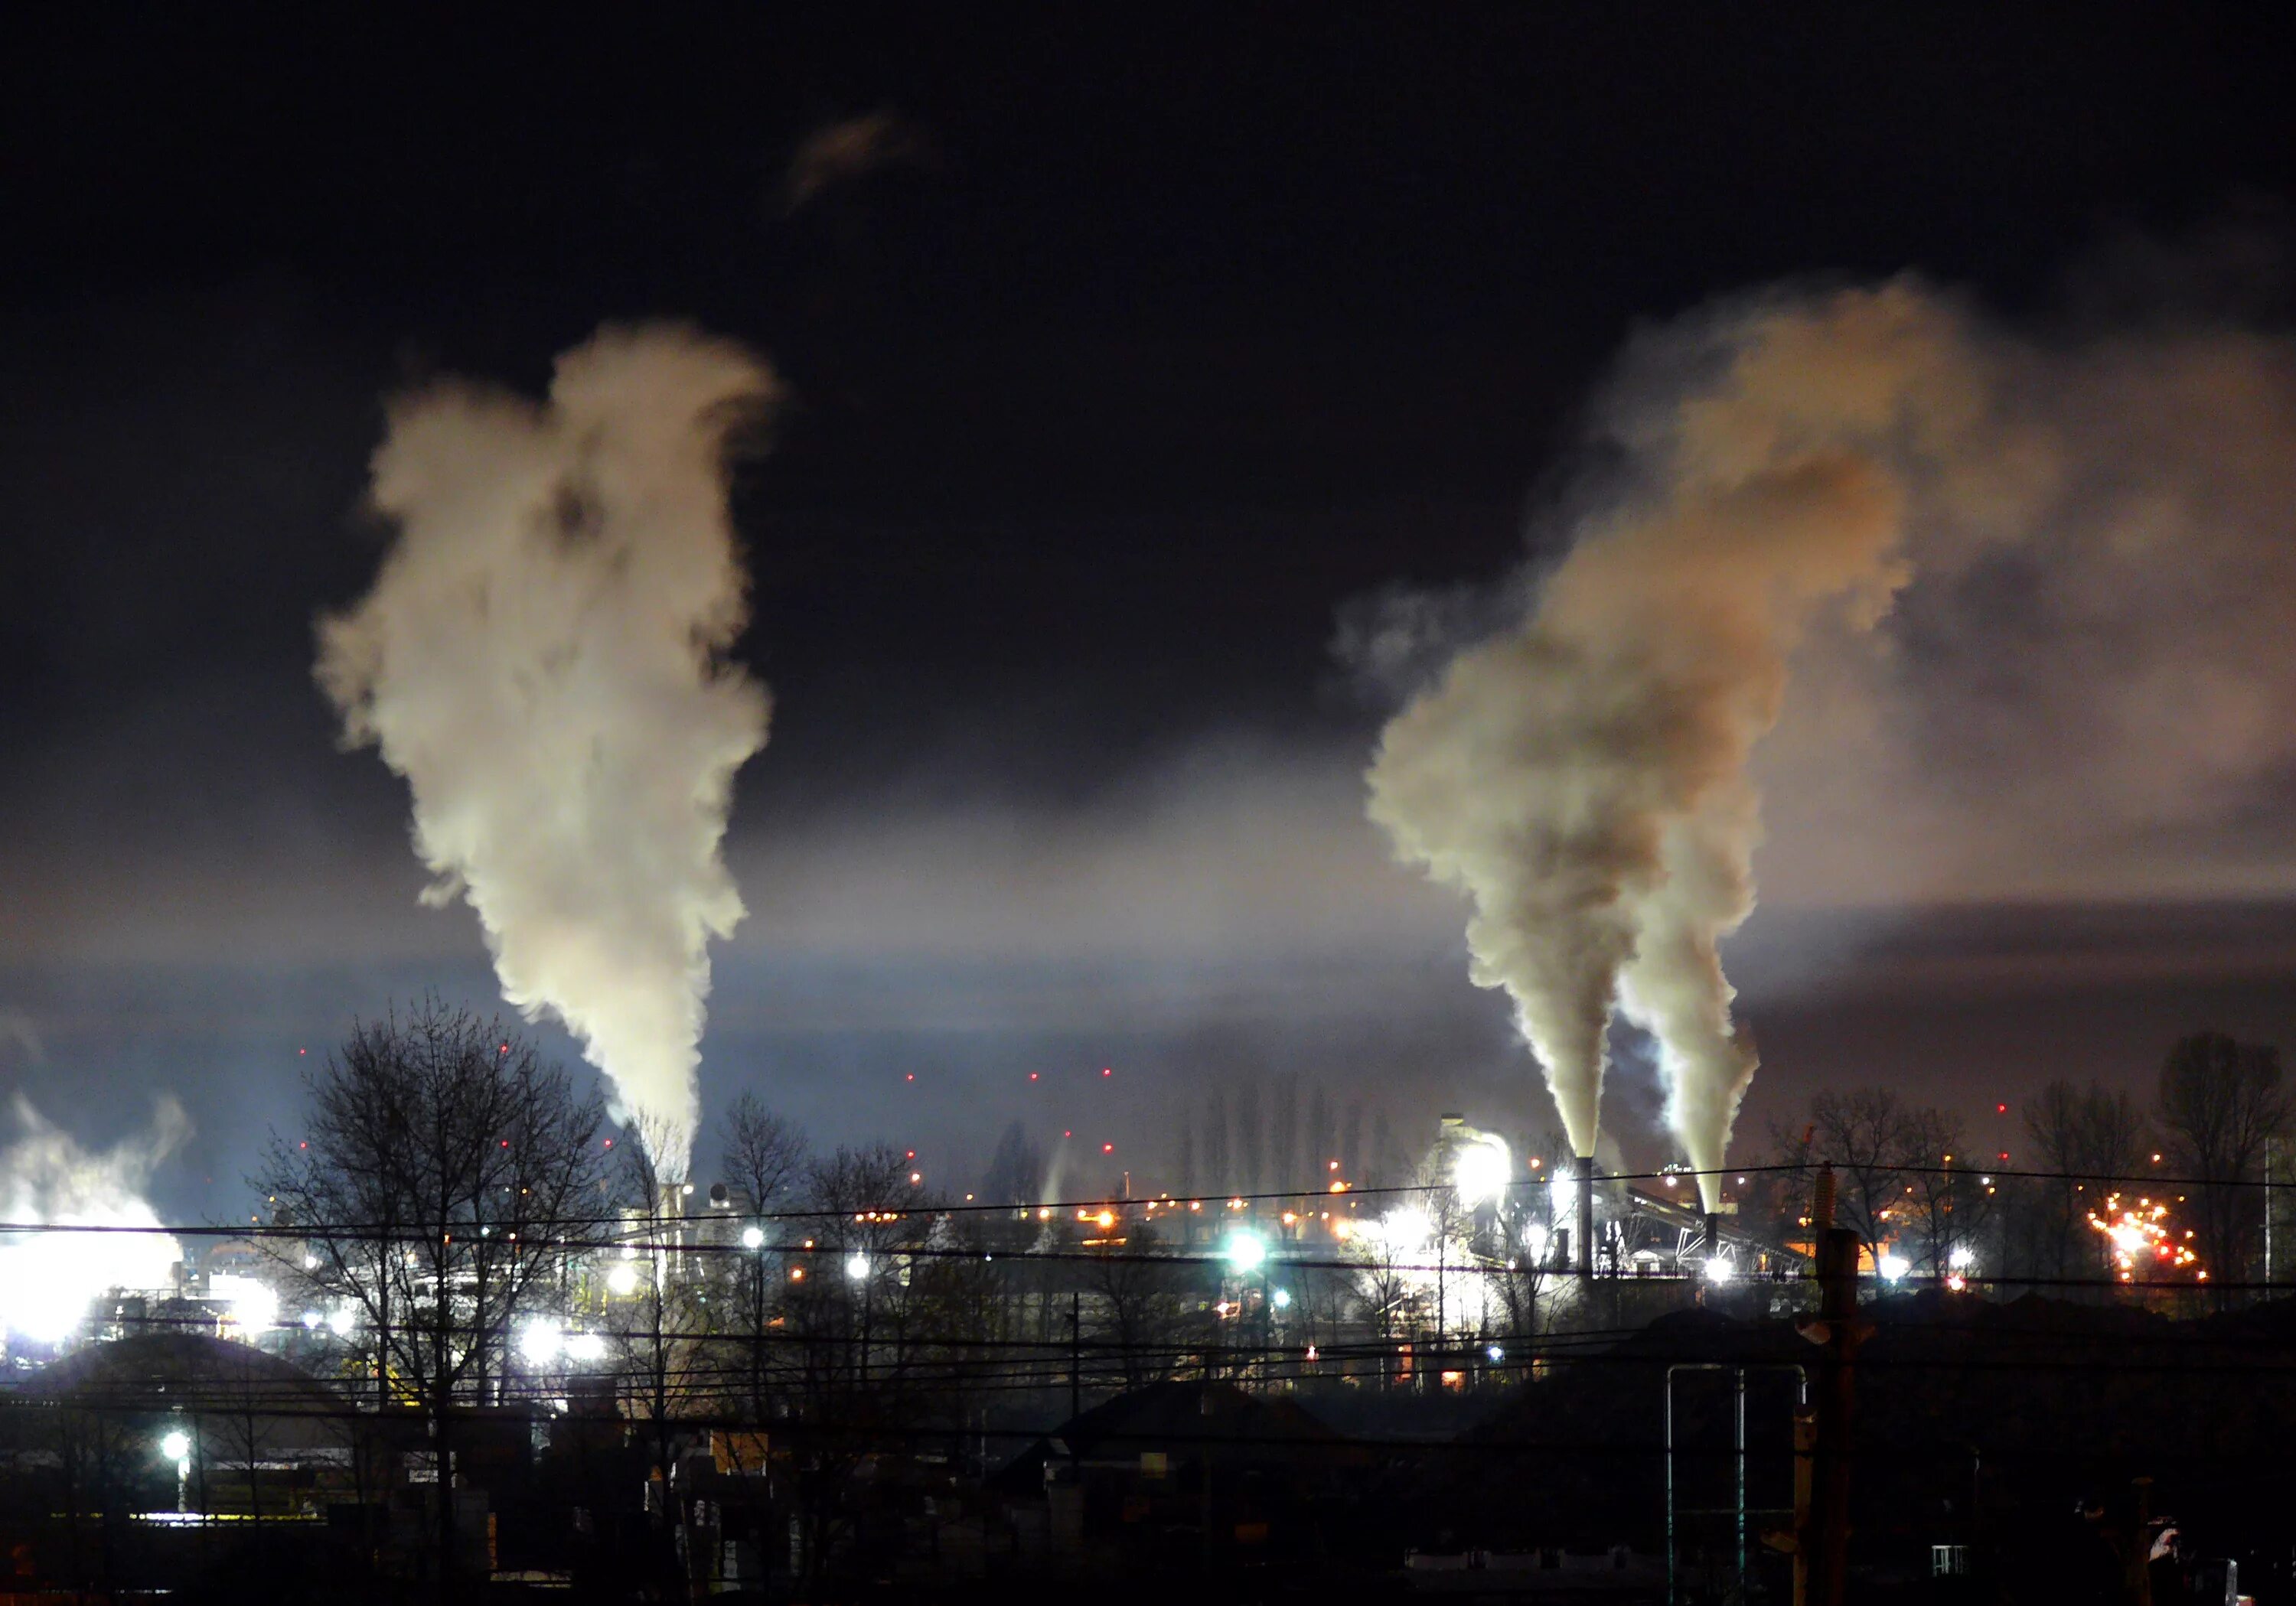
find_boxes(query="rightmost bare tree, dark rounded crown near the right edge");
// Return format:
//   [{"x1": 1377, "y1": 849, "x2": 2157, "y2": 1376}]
[{"x1": 2158, "y1": 1032, "x2": 2291, "y2": 1287}]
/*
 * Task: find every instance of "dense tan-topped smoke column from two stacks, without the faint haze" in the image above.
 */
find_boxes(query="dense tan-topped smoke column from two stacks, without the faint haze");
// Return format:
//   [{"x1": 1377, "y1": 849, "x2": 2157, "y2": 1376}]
[{"x1": 1368, "y1": 285, "x2": 1977, "y2": 1211}]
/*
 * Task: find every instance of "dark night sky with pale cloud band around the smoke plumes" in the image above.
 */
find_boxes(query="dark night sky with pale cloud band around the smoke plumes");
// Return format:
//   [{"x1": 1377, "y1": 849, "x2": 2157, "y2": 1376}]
[{"x1": 0, "y1": 7, "x2": 2296, "y2": 1211}]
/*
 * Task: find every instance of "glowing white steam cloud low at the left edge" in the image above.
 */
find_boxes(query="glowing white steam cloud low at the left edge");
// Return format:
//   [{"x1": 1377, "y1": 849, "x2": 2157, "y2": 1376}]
[{"x1": 0, "y1": 1094, "x2": 191, "y2": 1342}]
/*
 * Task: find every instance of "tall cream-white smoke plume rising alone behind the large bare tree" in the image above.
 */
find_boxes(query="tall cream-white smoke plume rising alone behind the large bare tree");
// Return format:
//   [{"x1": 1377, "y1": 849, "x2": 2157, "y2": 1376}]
[{"x1": 317, "y1": 326, "x2": 776, "y2": 1174}]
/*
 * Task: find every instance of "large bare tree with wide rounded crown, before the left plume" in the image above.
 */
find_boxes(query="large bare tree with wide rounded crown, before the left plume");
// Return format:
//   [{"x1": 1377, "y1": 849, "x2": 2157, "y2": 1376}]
[{"x1": 250, "y1": 998, "x2": 604, "y2": 1569}]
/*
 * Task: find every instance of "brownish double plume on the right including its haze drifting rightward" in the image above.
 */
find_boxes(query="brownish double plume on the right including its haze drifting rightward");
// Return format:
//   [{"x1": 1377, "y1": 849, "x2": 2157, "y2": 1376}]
[{"x1": 1368, "y1": 263, "x2": 2296, "y2": 1207}]
